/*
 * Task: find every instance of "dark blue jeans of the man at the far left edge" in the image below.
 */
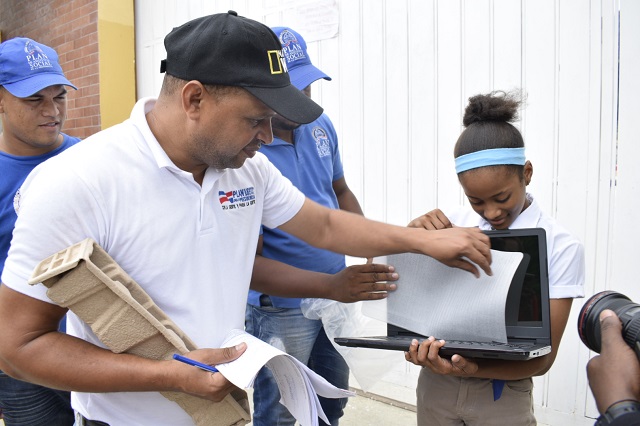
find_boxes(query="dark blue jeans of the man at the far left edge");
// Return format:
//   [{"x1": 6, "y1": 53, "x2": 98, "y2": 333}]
[{"x1": 0, "y1": 371, "x2": 75, "y2": 426}]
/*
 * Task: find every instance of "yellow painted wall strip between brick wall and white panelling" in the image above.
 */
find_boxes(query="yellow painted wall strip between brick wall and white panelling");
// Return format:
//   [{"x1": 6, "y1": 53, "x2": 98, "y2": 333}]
[{"x1": 98, "y1": 0, "x2": 136, "y2": 129}]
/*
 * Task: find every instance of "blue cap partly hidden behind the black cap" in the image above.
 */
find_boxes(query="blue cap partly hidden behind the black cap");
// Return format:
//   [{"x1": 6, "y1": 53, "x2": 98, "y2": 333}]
[{"x1": 271, "y1": 27, "x2": 331, "y2": 90}]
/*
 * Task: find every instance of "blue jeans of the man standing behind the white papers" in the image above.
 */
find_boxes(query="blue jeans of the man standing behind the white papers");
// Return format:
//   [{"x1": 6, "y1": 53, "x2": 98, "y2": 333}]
[{"x1": 245, "y1": 305, "x2": 349, "y2": 426}]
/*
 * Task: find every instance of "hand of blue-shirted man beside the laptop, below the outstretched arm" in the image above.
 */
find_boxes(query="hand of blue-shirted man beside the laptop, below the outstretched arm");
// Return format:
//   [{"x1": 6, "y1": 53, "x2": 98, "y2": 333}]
[{"x1": 329, "y1": 263, "x2": 398, "y2": 303}]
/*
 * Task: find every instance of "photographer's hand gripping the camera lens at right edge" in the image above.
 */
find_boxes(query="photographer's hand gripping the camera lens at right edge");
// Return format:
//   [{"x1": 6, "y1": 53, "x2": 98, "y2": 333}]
[{"x1": 587, "y1": 309, "x2": 640, "y2": 413}]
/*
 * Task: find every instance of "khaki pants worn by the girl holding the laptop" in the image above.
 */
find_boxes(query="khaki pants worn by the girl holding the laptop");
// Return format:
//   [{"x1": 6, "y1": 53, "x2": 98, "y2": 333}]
[{"x1": 416, "y1": 368, "x2": 536, "y2": 426}]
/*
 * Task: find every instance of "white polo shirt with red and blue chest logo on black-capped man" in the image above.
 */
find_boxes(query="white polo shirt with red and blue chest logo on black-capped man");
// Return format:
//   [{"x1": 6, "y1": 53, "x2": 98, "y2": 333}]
[{"x1": 2, "y1": 98, "x2": 304, "y2": 426}]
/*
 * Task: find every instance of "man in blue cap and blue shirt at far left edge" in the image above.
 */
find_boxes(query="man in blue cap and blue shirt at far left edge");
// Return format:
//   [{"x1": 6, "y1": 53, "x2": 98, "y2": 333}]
[{"x1": 0, "y1": 38, "x2": 80, "y2": 426}]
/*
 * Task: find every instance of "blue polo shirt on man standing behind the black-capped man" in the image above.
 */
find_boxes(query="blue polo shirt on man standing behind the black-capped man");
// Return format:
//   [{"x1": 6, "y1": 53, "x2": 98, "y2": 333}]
[{"x1": 248, "y1": 114, "x2": 346, "y2": 308}]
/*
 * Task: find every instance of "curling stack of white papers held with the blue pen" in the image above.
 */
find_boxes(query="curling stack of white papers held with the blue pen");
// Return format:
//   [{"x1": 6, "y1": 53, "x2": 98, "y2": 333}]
[{"x1": 216, "y1": 330, "x2": 355, "y2": 426}]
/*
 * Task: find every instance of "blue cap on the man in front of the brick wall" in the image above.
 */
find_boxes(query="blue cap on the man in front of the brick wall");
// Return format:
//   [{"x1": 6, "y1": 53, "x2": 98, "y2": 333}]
[{"x1": 0, "y1": 37, "x2": 78, "y2": 98}]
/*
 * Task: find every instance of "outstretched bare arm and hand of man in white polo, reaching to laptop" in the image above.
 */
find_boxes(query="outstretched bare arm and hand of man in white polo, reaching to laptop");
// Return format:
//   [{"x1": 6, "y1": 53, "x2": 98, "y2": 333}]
[{"x1": 279, "y1": 199, "x2": 491, "y2": 275}]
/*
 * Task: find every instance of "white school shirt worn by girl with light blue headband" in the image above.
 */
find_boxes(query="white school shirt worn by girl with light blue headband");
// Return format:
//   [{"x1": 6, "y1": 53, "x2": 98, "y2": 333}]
[{"x1": 444, "y1": 194, "x2": 585, "y2": 299}]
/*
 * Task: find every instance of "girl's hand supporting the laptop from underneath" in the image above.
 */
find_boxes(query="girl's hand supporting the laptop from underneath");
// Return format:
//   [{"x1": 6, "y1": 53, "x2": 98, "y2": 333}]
[{"x1": 404, "y1": 337, "x2": 478, "y2": 377}]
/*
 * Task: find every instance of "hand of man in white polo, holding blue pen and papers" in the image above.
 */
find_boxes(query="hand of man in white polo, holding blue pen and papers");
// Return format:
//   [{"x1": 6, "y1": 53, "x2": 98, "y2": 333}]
[{"x1": 167, "y1": 343, "x2": 247, "y2": 402}]
